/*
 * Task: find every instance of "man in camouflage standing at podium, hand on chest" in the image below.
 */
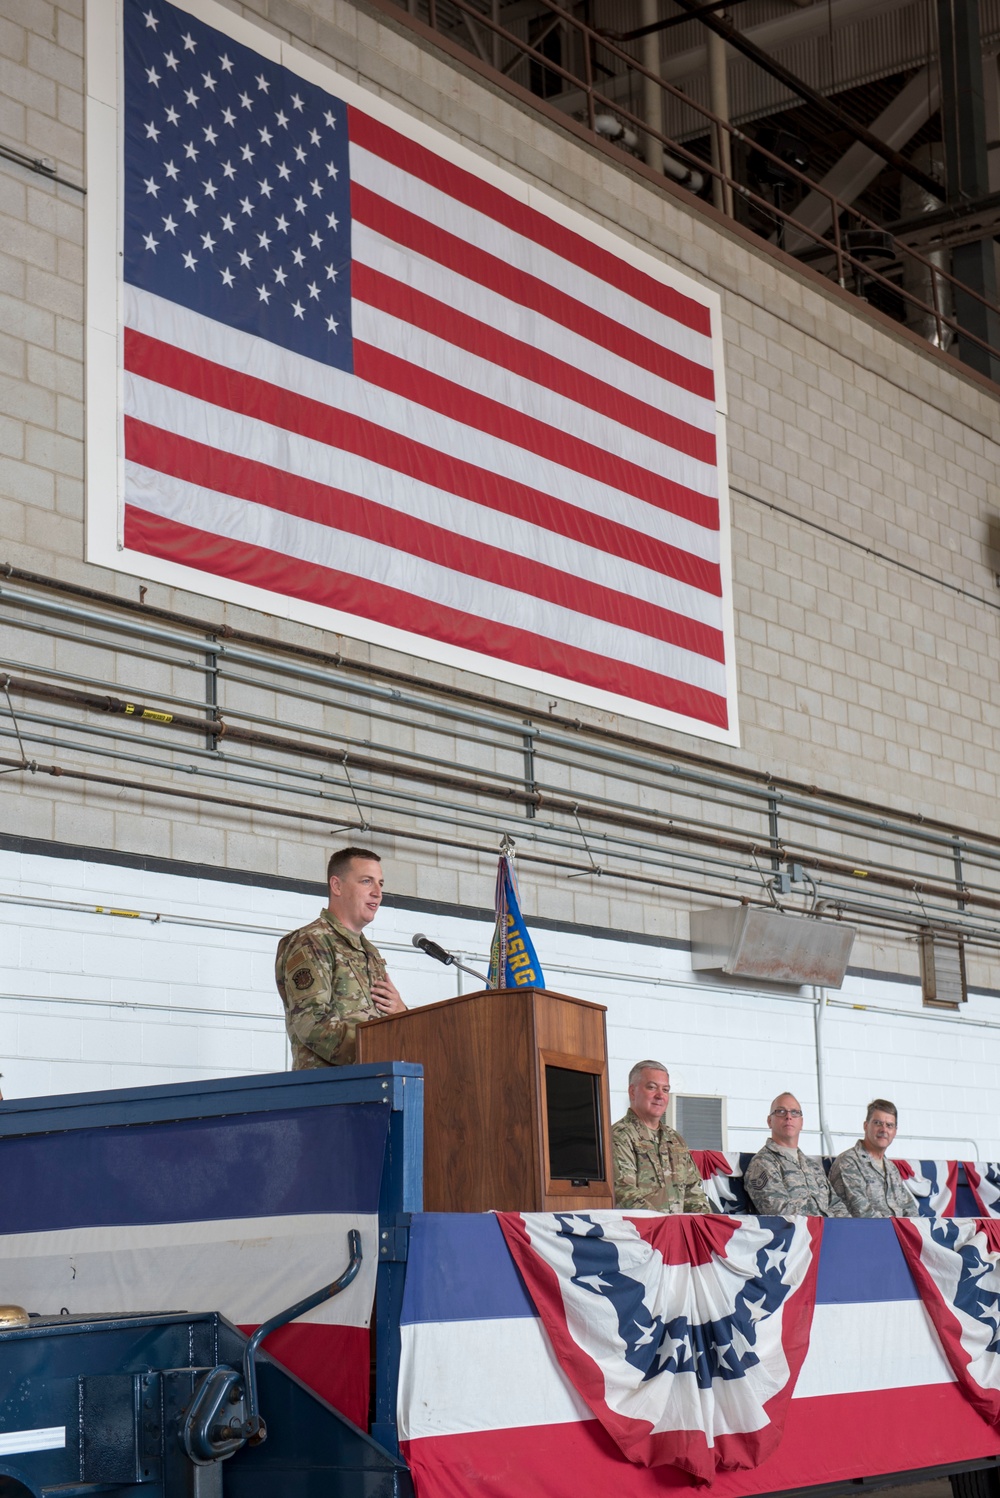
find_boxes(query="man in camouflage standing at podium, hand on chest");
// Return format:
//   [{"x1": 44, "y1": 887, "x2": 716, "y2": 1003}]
[{"x1": 274, "y1": 848, "x2": 406, "y2": 1071}]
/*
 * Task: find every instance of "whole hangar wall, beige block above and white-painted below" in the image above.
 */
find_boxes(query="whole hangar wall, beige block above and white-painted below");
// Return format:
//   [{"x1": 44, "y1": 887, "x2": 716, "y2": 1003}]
[{"x1": 0, "y1": 0, "x2": 1000, "y2": 1126}]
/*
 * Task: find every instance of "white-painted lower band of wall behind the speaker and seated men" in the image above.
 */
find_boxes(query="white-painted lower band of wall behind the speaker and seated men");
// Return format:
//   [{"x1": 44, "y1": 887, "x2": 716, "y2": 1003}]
[{"x1": 0, "y1": 851, "x2": 1000, "y2": 1159}]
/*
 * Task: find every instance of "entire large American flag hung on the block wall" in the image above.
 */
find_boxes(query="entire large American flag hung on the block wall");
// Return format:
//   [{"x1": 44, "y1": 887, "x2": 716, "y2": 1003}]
[{"x1": 120, "y1": 0, "x2": 735, "y2": 737}]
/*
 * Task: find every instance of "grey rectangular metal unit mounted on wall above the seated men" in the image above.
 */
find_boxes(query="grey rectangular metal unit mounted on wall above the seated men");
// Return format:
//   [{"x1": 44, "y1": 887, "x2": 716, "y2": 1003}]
[{"x1": 690, "y1": 905, "x2": 855, "y2": 989}]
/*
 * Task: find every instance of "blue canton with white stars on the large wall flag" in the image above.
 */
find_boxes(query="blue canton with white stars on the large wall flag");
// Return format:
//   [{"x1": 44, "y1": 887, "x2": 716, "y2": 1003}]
[{"x1": 124, "y1": 0, "x2": 353, "y2": 370}]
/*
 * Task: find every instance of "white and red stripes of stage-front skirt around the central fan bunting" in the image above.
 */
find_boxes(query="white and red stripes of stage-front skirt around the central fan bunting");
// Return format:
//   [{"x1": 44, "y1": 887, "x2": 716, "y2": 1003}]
[{"x1": 400, "y1": 1264, "x2": 976, "y2": 1498}]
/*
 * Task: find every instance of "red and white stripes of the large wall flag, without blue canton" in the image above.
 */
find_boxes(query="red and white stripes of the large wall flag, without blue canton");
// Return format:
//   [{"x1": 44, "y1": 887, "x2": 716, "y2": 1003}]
[{"x1": 123, "y1": 96, "x2": 734, "y2": 731}]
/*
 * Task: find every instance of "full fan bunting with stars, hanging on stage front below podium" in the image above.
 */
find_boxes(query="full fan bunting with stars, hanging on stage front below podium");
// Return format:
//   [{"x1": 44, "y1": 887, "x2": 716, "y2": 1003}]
[{"x1": 499, "y1": 1212, "x2": 823, "y2": 1482}]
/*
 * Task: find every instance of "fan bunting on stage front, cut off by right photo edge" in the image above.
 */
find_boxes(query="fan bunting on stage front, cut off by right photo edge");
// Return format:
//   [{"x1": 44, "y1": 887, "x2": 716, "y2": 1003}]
[{"x1": 894, "y1": 1218, "x2": 1000, "y2": 1428}]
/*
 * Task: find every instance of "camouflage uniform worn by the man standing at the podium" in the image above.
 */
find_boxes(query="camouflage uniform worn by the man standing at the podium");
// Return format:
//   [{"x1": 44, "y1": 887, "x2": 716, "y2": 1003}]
[{"x1": 274, "y1": 911, "x2": 386, "y2": 1071}]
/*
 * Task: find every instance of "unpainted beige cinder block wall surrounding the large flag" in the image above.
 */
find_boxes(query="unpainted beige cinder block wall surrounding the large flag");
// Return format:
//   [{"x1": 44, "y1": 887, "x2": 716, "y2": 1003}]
[{"x1": 0, "y1": 0, "x2": 1000, "y2": 1084}]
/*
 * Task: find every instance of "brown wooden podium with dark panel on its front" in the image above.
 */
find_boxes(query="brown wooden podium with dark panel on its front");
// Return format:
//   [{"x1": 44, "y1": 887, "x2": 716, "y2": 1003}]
[{"x1": 358, "y1": 989, "x2": 614, "y2": 1212}]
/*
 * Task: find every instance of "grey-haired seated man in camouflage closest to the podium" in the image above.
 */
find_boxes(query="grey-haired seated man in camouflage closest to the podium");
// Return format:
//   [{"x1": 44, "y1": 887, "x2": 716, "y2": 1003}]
[{"x1": 611, "y1": 1061, "x2": 713, "y2": 1212}]
